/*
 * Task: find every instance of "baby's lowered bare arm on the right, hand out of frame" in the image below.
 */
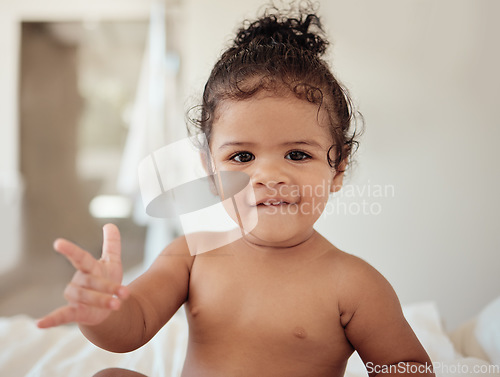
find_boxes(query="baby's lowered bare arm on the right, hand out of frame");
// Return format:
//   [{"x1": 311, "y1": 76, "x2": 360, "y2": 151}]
[{"x1": 339, "y1": 257, "x2": 434, "y2": 377}]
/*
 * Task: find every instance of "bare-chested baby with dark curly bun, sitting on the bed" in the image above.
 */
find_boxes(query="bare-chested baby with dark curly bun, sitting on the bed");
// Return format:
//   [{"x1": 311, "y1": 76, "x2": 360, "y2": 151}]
[{"x1": 38, "y1": 3, "x2": 433, "y2": 377}]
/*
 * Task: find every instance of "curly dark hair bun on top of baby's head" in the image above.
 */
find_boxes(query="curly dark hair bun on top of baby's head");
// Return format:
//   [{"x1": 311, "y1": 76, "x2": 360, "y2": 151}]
[{"x1": 234, "y1": 3, "x2": 328, "y2": 56}]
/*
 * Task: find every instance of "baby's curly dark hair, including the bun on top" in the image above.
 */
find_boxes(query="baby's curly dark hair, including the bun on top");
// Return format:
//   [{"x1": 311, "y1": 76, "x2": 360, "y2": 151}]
[{"x1": 189, "y1": 2, "x2": 358, "y2": 170}]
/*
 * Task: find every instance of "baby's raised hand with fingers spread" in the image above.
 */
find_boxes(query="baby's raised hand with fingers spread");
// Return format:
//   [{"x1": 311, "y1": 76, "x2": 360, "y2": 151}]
[{"x1": 37, "y1": 224, "x2": 129, "y2": 328}]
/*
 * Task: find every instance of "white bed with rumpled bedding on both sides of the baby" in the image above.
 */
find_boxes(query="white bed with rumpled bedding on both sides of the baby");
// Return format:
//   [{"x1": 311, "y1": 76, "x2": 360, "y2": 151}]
[{"x1": 0, "y1": 297, "x2": 500, "y2": 377}]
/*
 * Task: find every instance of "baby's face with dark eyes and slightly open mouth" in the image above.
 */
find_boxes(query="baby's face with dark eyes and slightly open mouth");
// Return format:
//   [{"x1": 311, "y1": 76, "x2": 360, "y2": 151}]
[{"x1": 210, "y1": 93, "x2": 342, "y2": 246}]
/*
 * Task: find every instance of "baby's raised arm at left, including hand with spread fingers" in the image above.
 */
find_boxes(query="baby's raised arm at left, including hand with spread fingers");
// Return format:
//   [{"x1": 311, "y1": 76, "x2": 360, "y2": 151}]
[{"x1": 37, "y1": 224, "x2": 191, "y2": 352}]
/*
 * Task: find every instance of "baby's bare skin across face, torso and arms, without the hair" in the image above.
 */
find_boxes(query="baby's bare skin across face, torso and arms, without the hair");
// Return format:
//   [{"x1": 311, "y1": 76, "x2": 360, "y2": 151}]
[{"x1": 38, "y1": 96, "x2": 433, "y2": 377}]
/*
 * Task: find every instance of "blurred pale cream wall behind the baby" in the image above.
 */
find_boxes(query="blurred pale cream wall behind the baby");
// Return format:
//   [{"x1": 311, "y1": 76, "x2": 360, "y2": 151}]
[{"x1": 0, "y1": 0, "x2": 500, "y2": 329}]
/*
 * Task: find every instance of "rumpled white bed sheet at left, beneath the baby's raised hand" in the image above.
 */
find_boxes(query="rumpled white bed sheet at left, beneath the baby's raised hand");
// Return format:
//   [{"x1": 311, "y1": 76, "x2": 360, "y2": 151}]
[{"x1": 0, "y1": 308, "x2": 187, "y2": 377}]
